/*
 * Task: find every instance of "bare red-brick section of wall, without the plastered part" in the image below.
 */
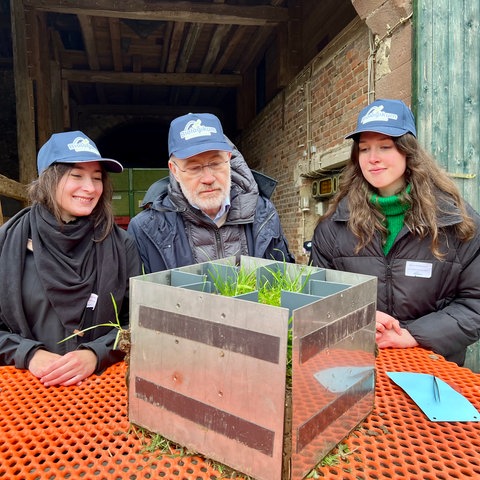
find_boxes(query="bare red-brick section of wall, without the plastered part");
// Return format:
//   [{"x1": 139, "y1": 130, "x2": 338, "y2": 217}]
[{"x1": 237, "y1": 21, "x2": 369, "y2": 263}]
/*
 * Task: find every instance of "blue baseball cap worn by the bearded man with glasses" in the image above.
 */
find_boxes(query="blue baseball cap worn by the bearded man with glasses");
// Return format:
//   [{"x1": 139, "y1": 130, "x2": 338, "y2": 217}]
[{"x1": 168, "y1": 113, "x2": 232, "y2": 159}]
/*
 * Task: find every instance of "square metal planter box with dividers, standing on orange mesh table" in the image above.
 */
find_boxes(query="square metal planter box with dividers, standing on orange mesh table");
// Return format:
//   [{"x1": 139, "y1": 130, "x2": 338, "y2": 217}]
[{"x1": 129, "y1": 257, "x2": 377, "y2": 480}]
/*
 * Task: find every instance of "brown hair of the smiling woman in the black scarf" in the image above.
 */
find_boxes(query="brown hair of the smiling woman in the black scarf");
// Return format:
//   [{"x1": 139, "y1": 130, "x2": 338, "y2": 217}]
[{"x1": 28, "y1": 162, "x2": 115, "y2": 242}]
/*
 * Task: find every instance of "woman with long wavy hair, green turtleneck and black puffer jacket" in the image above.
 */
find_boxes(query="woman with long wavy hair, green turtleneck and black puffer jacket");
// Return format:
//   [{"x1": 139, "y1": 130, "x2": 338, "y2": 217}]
[{"x1": 311, "y1": 99, "x2": 480, "y2": 365}]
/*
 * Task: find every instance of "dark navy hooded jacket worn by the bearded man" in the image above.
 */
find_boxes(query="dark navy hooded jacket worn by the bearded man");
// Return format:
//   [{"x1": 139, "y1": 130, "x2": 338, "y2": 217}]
[{"x1": 128, "y1": 148, "x2": 295, "y2": 272}]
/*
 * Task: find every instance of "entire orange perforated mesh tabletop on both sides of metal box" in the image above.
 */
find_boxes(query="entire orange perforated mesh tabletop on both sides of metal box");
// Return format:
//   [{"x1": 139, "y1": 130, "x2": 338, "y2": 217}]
[{"x1": 0, "y1": 348, "x2": 480, "y2": 480}]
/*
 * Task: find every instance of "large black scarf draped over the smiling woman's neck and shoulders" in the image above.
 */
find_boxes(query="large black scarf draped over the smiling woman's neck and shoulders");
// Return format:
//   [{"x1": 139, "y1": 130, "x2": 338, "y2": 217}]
[{"x1": 0, "y1": 205, "x2": 127, "y2": 338}]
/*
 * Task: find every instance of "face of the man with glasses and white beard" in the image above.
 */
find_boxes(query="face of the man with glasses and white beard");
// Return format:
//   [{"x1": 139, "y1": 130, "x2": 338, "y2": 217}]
[{"x1": 168, "y1": 150, "x2": 231, "y2": 218}]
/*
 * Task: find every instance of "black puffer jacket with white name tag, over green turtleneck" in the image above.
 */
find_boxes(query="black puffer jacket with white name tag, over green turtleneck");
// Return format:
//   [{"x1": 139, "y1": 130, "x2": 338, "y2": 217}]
[{"x1": 311, "y1": 195, "x2": 480, "y2": 365}]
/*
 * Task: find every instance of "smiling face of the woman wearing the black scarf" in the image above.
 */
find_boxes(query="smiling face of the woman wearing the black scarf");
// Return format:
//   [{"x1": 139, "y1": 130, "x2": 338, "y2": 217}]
[{"x1": 55, "y1": 162, "x2": 103, "y2": 222}]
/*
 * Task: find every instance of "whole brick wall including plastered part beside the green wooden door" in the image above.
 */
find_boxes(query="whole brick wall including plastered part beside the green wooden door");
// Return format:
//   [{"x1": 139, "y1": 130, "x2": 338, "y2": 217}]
[{"x1": 237, "y1": 0, "x2": 412, "y2": 263}]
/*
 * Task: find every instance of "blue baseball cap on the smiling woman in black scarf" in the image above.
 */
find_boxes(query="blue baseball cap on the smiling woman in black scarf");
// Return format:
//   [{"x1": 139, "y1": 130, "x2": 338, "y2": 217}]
[{"x1": 37, "y1": 130, "x2": 123, "y2": 175}]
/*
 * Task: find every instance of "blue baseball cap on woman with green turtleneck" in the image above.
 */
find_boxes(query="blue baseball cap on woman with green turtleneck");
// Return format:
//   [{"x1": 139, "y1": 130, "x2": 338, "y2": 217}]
[{"x1": 345, "y1": 99, "x2": 417, "y2": 138}]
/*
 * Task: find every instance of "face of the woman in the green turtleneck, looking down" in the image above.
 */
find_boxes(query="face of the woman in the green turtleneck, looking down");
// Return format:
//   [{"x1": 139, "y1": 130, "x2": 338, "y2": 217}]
[{"x1": 358, "y1": 132, "x2": 407, "y2": 197}]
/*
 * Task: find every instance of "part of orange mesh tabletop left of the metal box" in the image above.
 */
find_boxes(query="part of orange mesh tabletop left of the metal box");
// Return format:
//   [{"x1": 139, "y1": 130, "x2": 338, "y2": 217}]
[{"x1": 0, "y1": 364, "x2": 223, "y2": 480}]
